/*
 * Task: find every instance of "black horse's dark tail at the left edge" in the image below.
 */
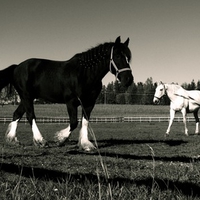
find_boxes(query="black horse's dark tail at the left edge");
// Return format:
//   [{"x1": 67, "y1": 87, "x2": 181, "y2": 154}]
[{"x1": 0, "y1": 65, "x2": 17, "y2": 91}]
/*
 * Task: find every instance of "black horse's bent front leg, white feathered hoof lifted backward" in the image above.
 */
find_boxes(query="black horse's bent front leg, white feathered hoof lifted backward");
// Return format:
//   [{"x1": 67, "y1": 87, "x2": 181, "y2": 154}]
[{"x1": 54, "y1": 103, "x2": 78, "y2": 146}]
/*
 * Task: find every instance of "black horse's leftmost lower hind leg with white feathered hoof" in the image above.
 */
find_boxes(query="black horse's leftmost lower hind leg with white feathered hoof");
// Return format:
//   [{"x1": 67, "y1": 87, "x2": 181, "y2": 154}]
[{"x1": 5, "y1": 103, "x2": 25, "y2": 144}]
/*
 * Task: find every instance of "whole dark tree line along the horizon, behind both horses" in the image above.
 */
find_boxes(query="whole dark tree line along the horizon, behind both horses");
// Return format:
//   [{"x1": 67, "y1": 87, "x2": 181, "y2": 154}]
[{"x1": 0, "y1": 77, "x2": 200, "y2": 105}]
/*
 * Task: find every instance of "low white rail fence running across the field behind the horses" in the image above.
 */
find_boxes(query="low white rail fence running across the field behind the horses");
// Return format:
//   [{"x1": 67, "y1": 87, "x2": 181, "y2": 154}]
[{"x1": 0, "y1": 116, "x2": 195, "y2": 124}]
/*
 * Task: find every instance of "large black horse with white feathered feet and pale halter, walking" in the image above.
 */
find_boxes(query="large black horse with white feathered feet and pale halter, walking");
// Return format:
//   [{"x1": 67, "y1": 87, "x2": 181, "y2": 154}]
[{"x1": 0, "y1": 37, "x2": 133, "y2": 151}]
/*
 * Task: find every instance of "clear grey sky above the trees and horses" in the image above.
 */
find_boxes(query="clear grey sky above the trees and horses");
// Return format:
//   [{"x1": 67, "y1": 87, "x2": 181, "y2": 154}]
[{"x1": 0, "y1": 0, "x2": 200, "y2": 85}]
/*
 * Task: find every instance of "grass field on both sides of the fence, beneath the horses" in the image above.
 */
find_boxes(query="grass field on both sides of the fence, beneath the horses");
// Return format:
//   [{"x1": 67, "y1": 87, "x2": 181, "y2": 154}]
[{"x1": 0, "y1": 105, "x2": 200, "y2": 200}]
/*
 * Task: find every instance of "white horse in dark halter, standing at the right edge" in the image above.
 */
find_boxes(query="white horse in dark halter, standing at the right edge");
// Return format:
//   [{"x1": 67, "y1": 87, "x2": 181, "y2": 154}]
[{"x1": 153, "y1": 82, "x2": 200, "y2": 135}]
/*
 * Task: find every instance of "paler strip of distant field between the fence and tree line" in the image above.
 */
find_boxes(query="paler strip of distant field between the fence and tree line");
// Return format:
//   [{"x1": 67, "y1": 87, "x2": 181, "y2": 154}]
[{"x1": 0, "y1": 104, "x2": 181, "y2": 117}]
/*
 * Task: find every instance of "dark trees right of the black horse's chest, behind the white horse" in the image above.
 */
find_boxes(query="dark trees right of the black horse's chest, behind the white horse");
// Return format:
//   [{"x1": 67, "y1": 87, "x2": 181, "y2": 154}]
[{"x1": 97, "y1": 77, "x2": 200, "y2": 105}]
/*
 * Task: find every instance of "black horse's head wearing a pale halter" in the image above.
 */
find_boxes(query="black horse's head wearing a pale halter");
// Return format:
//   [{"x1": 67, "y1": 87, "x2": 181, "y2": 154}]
[{"x1": 109, "y1": 37, "x2": 133, "y2": 87}]
